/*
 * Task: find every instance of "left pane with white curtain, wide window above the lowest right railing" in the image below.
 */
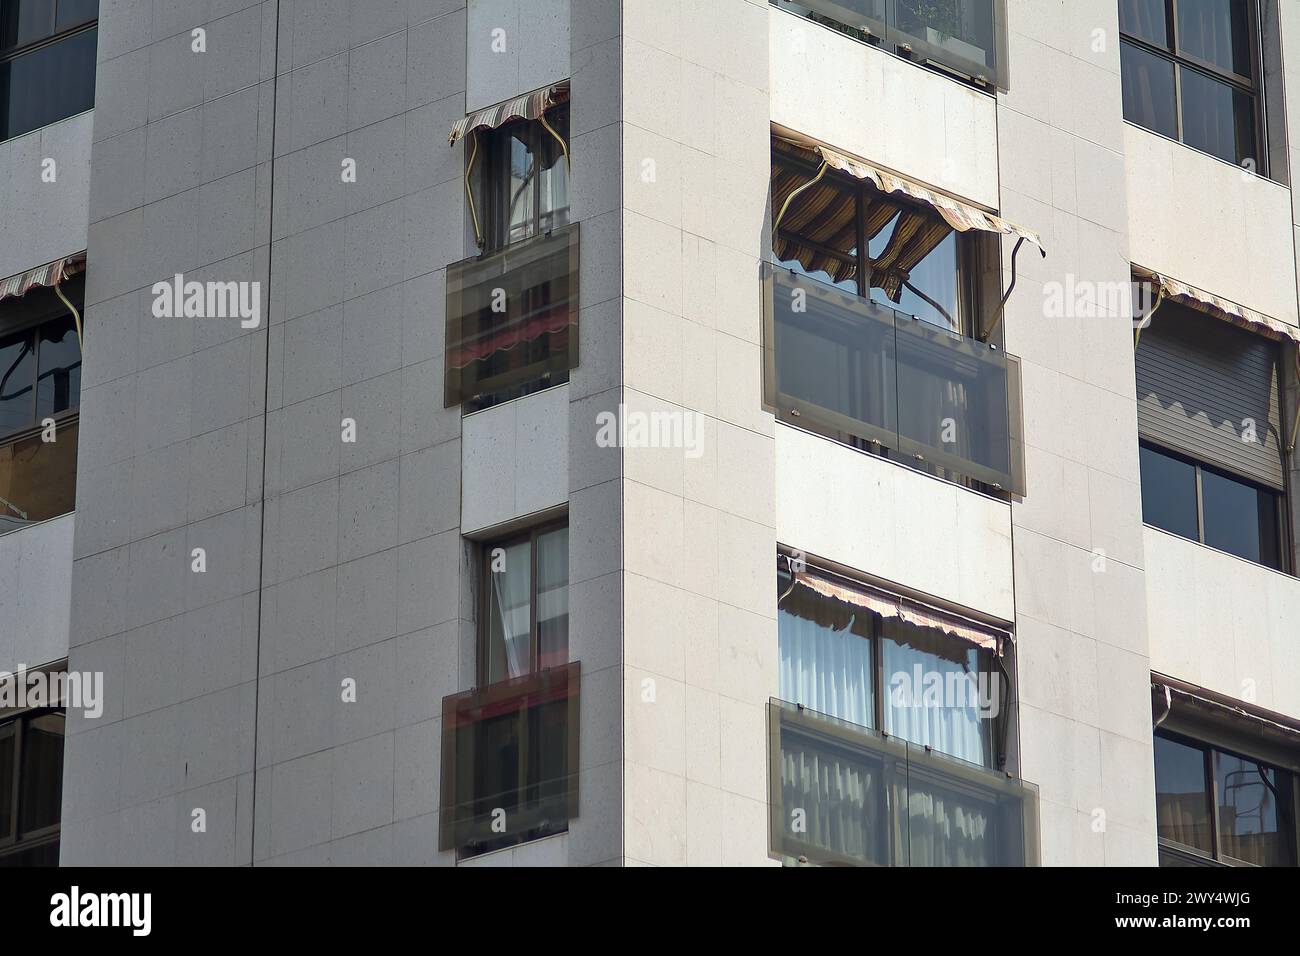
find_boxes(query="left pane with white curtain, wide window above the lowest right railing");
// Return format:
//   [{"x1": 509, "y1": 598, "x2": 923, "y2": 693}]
[{"x1": 776, "y1": 579, "x2": 876, "y2": 727}]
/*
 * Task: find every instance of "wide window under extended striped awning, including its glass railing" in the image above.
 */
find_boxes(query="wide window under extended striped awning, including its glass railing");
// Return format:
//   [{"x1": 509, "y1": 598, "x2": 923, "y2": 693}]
[{"x1": 764, "y1": 139, "x2": 1023, "y2": 494}]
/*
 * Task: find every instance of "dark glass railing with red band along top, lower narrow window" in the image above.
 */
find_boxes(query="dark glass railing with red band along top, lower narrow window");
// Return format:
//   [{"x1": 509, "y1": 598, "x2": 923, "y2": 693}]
[{"x1": 438, "y1": 662, "x2": 580, "y2": 857}]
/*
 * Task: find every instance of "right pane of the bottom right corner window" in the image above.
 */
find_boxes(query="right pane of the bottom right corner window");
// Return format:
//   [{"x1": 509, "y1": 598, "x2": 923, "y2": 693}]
[{"x1": 1214, "y1": 752, "x2": 1295, "y2": 866}]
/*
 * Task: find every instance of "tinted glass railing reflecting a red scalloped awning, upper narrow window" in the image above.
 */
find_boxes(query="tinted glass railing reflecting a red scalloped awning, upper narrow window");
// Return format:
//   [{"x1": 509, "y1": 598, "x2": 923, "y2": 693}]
[{"x1": 445, "y1": 222, "x2": 579, "y2": 412}]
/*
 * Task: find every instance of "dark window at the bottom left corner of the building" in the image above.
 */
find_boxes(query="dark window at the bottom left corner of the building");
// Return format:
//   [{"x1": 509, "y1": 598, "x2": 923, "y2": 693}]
[{"x1": 0, "y1": 709, "x2": 64, "y2": 866}]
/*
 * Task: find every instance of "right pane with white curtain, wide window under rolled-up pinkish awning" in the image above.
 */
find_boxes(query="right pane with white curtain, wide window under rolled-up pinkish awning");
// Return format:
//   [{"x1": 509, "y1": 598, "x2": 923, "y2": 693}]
[{"x1": 880, "y1": 619, "x2": 1002, "y2": 766}]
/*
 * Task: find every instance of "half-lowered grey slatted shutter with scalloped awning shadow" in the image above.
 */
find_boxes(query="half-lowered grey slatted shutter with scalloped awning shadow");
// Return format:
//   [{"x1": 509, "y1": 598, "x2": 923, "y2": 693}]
[{"x1": 1136, "y1": 302, "x2": 1283, "y2": 490}]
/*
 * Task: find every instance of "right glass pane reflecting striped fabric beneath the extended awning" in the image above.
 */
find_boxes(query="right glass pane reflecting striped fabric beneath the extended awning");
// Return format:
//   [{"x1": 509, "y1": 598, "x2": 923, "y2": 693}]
[{"x1": 867, "y1": 209, "x2": 962, "y2": 332}]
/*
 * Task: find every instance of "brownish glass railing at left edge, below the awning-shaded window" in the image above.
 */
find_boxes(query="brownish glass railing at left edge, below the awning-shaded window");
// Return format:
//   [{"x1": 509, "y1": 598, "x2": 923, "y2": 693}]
[{"x1": 0, "y1": 418, "x2": 78, "y2": 535}]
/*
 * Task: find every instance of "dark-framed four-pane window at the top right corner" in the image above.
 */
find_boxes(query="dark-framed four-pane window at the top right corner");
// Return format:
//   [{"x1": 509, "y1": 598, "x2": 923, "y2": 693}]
[{"x1": 1119, "y1": 0, "x2": 1281, "y2": 176}]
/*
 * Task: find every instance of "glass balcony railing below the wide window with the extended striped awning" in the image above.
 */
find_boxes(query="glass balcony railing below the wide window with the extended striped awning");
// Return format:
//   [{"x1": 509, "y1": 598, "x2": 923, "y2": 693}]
[{"x1": 763, "y1": 264, "x2": 1024, "y2": 494}]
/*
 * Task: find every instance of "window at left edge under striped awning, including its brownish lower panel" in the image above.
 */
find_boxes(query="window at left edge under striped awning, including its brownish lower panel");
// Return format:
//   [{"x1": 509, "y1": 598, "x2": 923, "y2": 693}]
[{"x1": 0, "y1": 276, "x2": 85, "y2": 533}]
